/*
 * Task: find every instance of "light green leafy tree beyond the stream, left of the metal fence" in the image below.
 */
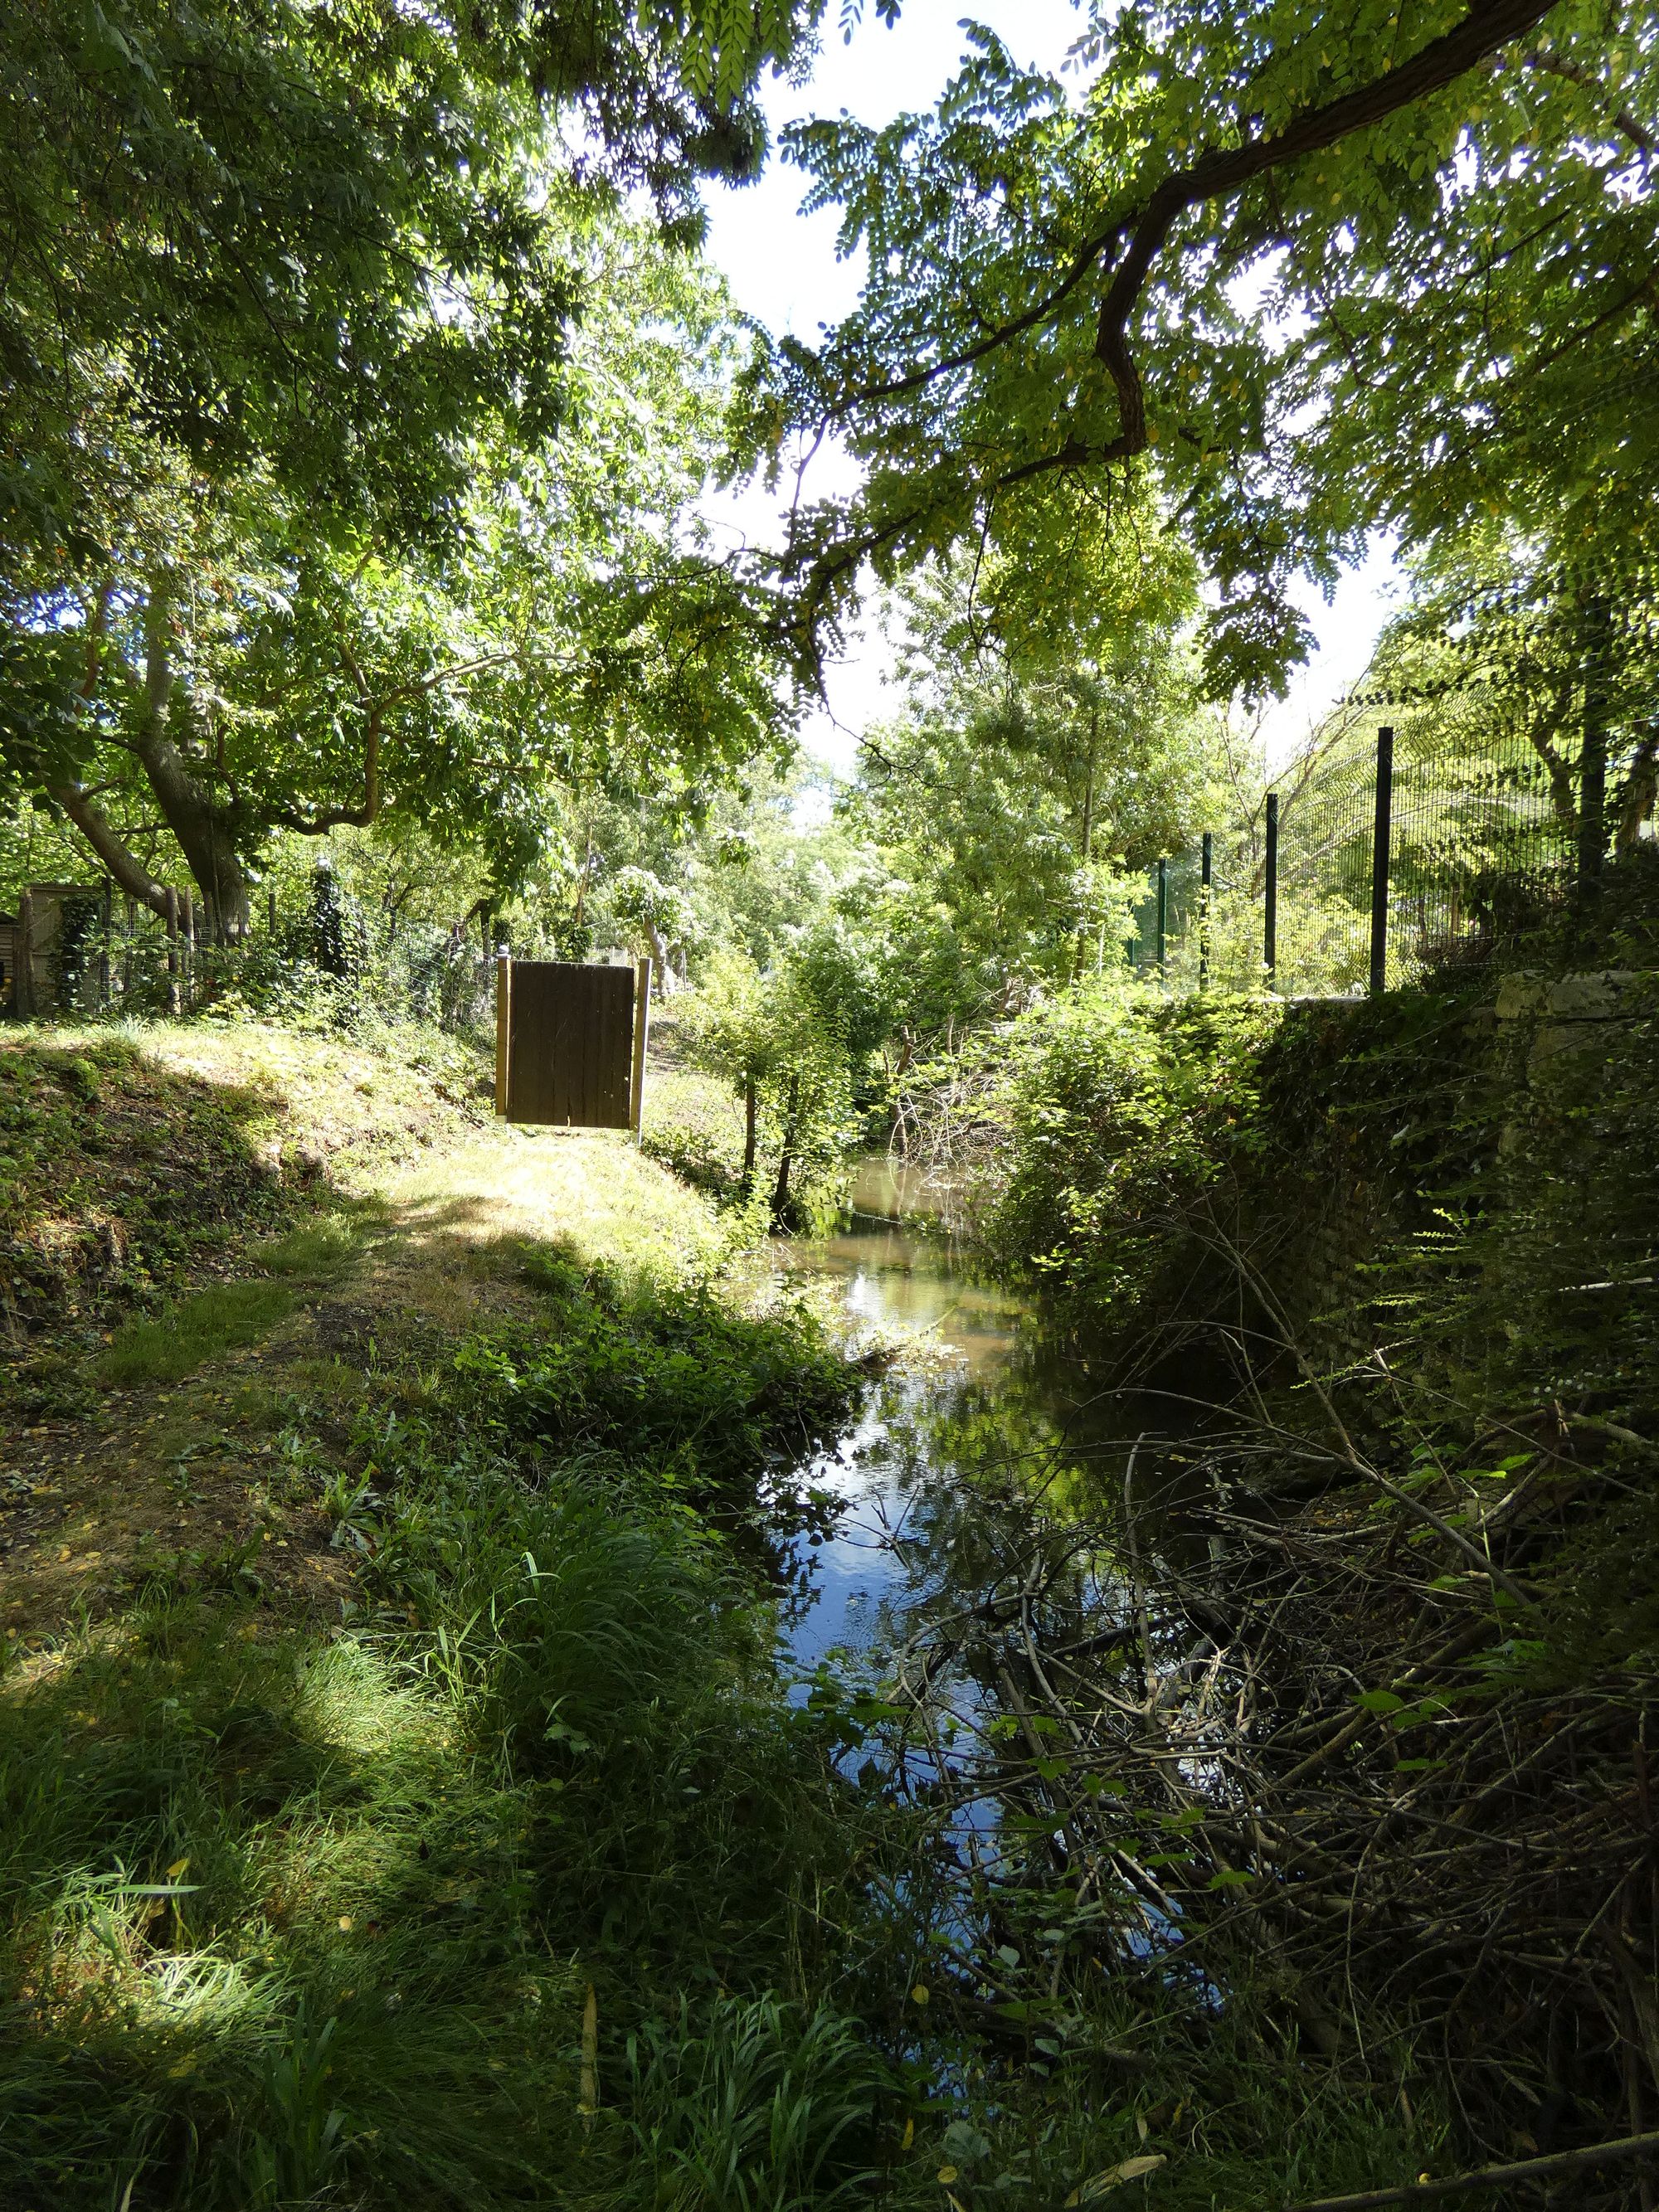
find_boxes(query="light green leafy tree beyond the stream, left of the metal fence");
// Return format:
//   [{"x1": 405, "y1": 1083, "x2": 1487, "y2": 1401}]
[{"x1": 847, "y1": 524, "x2": 1219, "y2": 1033}]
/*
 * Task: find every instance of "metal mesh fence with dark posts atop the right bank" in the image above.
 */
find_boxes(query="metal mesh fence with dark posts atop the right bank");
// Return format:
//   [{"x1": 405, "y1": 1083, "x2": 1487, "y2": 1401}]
[{"x1": 1128, "y1": 593, "x2": 1659, "y2": 998}]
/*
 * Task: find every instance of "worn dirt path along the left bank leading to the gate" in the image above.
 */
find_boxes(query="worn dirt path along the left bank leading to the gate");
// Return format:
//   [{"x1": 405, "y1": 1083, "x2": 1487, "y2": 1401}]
[{"x1": 0, "y1": 1128, "x2": 719, "y2": 1646}]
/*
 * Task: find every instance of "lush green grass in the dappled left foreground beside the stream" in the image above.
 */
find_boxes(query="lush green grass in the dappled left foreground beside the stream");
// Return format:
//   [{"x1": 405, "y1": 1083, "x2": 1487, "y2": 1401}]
[{"x1": 0, "y1": 1335, "x2": 902, "y2": 2212}]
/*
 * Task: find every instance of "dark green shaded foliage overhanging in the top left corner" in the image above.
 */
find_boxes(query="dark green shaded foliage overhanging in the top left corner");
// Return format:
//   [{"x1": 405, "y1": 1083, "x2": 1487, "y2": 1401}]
[{"x1": 0, "y1": 0, "x2": 819, "y2": 581}]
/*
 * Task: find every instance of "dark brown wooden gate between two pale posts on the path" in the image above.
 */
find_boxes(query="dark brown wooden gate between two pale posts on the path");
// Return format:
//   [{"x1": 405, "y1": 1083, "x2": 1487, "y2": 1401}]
[{"x1": 495, "y1": 960, "x2": 650, "y2": 1130}]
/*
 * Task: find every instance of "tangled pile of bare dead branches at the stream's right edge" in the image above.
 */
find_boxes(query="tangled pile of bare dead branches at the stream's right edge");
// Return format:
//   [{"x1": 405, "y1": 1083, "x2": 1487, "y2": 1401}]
[{"x1": 876, "y1": 1400, "x2": 1659, "y2": 2212}]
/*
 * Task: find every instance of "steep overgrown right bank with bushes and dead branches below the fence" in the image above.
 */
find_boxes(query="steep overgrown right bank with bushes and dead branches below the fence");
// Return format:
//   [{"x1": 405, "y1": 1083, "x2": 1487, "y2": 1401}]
[{"x1": 924, "y1": 969, "x2": 1659, "y2": 2208}]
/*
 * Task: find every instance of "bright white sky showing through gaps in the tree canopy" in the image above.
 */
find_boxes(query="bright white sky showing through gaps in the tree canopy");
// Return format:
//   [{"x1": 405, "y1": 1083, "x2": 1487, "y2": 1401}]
[{"x1": 708, "y1": 0, "x2": 1391, "y2": 774}]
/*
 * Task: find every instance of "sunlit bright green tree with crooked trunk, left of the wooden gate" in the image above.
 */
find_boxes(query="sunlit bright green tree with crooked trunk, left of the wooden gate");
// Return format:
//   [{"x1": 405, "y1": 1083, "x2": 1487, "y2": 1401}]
[{"x1": 0, "y1": 199, "x2": 783, "y2": 938}]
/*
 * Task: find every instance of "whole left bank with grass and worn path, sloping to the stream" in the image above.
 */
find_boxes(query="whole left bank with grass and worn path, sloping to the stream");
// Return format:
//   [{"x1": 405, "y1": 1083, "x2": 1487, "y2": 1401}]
[{"x1": 0, "y1": 1033, "x2": 902, "y2": 2208}]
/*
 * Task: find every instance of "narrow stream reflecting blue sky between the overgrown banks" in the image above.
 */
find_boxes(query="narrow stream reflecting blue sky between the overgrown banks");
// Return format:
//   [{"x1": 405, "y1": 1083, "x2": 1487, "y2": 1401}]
[{"x1": 774, "y1": 1159, "x2": 1217, "y2": 1991}]
